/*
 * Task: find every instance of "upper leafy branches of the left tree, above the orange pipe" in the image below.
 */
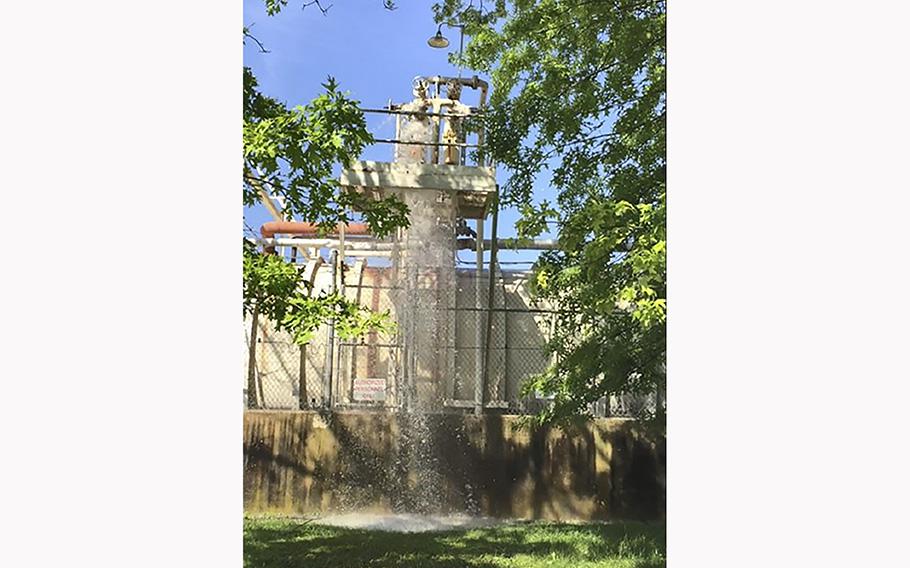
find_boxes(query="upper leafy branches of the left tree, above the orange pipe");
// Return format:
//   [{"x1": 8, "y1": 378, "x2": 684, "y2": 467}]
[{"x1": 243, "y1": 0, "x2": 408, "y2": 242}]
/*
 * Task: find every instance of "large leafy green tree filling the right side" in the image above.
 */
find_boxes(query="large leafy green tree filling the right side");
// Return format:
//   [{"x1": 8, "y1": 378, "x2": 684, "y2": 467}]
[{"x1": 434, "y1": 0, "x2": 666, "y2": 421}]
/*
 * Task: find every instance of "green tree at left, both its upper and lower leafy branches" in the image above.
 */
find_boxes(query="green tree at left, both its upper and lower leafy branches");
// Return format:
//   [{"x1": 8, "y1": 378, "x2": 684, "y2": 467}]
[{"x1": 243, "y1": 0, "x2": 408, "y2": 394}]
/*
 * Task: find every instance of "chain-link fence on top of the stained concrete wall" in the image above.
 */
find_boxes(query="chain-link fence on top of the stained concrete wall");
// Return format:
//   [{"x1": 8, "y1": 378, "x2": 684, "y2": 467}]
[{"x1": 243, "y1": 266, "x2": 662, "y2": 416}]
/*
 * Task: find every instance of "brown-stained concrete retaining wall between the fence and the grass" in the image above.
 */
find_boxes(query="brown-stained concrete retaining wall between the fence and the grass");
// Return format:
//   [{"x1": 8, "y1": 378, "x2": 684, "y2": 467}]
[{"x1": 243, "y1": 411, "x2": 666, "y2": 520}]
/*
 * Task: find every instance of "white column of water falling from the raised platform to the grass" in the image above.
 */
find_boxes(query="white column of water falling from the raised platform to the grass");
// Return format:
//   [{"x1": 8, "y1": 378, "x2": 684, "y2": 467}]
[{"x1": 320, "y1": 96, "x2": 478, "y2": 531}]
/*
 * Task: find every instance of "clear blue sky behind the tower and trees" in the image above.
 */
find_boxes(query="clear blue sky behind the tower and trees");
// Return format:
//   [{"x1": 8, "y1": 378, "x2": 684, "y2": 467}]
[{"x1": 243, "y1": 0, "x2": 552, "y2": 269}]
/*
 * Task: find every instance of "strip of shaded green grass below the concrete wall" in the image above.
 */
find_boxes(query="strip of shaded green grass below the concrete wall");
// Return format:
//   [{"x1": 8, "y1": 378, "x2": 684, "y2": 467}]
[{"x1": 243, "y1": 517, "x2": 666, "y2": 568}]
